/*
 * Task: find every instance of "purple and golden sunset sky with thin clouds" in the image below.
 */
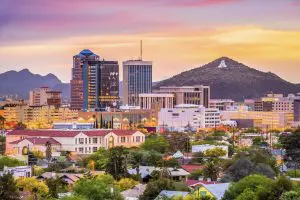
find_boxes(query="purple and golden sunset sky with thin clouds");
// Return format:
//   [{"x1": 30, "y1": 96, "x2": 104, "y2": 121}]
[{"x1": 0, "y1": 0, "x2": 300, "y2": 83}]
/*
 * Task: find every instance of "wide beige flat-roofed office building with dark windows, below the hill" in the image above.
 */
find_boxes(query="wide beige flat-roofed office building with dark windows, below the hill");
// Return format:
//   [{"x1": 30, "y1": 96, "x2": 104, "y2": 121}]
[{"x1": 153, "y1": 85, "x2": 210, "y2": 108}]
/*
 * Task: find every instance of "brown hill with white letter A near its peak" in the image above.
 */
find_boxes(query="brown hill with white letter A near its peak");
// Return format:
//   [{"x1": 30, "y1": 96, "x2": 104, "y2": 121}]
[{"x1": 154, "y1": 57, "x2": 300, "y2": 101}]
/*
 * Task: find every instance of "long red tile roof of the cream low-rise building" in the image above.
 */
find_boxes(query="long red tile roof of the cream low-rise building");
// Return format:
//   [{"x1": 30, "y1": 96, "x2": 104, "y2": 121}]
[{"x1": 7, "y1": 129, "x2": 137, "y2": 137}]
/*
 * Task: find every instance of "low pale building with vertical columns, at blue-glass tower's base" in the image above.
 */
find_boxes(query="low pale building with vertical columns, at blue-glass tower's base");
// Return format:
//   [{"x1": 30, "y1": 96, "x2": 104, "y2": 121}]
[{"x1": 139, "y1": 93, "x2": 174, "y2": 109}]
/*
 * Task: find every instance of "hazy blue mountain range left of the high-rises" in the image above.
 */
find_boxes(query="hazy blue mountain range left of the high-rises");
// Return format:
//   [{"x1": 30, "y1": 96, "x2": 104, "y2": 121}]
[{"x1": 0, "y1": 69, "x2": 70, "y2": 98}]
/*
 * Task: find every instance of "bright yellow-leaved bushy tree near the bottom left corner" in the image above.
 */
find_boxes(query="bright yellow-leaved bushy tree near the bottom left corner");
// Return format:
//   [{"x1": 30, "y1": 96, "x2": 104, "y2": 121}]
[{"x1": 17, "y1": 177, "x2": 49, "y2": 199}]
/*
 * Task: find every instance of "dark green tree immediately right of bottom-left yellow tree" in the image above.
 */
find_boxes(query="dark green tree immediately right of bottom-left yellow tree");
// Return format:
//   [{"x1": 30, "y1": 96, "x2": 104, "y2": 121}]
[{"x1": 45, "y1": 177, "x2": 68, "y2": 198}]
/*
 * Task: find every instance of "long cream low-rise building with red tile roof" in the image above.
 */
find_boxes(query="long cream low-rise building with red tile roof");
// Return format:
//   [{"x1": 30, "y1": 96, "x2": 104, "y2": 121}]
[{"x1": 6, "y1": 129, "x2": 145, "y2": 154}]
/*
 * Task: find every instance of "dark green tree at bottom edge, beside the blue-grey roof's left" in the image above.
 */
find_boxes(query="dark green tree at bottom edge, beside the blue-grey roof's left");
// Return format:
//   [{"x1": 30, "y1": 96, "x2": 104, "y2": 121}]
[{"x1": 140, "y1": 178, "x2": 175, "y2": 200}]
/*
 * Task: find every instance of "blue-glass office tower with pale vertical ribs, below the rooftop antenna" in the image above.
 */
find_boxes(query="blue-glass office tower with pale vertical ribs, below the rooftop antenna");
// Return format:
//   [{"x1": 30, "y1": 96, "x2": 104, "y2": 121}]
[{"x1": 123, "y1": 59, "x2": 152, "y2": 106}]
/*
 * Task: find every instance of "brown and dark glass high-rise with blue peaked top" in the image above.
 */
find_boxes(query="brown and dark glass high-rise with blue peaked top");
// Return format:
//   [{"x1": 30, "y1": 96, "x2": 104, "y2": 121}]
[{"x1": 71, "y1": 49, "x2": 119, "y2": 111}]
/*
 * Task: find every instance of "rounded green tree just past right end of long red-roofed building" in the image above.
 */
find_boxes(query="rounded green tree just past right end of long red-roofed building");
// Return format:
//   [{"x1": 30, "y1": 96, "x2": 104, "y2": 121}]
[{"x1": 141, "y1": 136, "x2": 169, "y2": 153}]
